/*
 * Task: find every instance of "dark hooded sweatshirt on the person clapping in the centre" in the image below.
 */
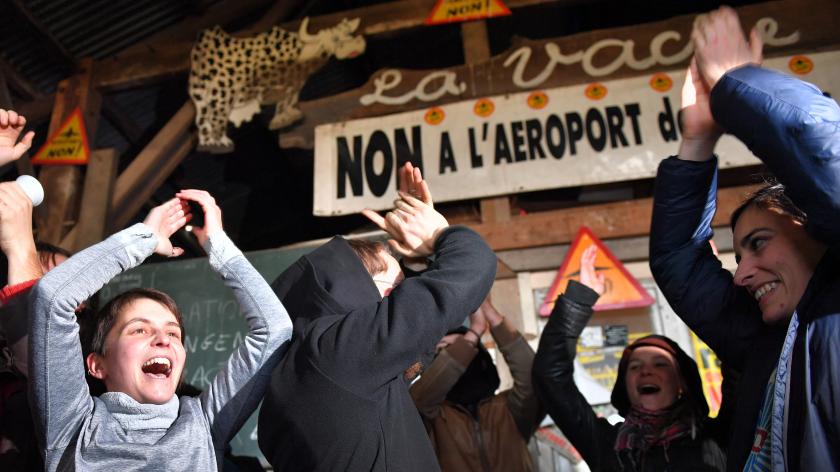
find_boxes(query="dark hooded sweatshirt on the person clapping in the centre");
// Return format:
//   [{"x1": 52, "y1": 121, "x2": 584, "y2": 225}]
[{"x1": 259, "y1": 227, "x2": 496, "y2": 471}]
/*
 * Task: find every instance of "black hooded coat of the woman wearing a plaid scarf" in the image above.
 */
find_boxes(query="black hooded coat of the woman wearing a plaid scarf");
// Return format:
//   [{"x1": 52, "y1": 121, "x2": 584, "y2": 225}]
[{"x1": 533, "y1": 280, "x2": 723, "y2": 472}]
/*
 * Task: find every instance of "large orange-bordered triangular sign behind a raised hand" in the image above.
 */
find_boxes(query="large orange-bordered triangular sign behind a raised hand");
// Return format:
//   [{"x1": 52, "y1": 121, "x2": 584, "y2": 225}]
[{"x1": 540, "y1": 226, "x2": 653, "y2": 316}]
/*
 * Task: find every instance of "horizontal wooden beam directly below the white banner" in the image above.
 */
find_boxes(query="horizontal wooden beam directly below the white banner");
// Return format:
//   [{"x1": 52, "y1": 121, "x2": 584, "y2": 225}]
[{"x1": 467, "y1": 185, "x2": 757, "y2": 251}]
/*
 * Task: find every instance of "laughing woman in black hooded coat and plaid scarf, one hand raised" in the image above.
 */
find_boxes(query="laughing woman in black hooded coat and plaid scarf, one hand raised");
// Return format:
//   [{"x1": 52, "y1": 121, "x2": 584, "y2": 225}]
[{"x1": 533, "y1": 246, "x2": 725, "y2": 472}]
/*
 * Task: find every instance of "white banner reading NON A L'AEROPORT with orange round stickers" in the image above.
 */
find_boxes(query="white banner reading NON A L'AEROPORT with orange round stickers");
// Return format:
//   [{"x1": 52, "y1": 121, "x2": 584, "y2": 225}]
[{"x1": 314, "y1": 51, "x2": 840, "y2": 216}]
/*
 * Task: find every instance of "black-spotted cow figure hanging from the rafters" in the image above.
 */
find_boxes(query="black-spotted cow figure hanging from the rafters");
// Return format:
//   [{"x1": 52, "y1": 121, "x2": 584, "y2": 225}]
[{"x1": 189, "y1": 18, "x2": 365, "y2": 153}]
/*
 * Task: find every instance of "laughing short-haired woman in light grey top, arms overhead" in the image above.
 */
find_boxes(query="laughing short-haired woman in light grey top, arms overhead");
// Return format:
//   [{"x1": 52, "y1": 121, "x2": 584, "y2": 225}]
[{"x1": 29, "y1": 190, "x2": 292, "y2": 471}]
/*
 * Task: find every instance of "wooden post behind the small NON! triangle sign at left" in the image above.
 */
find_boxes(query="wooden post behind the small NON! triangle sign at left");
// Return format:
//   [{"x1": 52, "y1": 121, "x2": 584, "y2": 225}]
[{"x1": 35, "y1": 59, "x2": 101, "y2": 244}]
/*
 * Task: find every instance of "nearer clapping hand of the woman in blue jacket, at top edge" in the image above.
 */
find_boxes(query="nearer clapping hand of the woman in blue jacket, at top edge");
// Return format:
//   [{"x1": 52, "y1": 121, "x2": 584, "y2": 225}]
[{"x1": 691, "y1": 7, "x2": 763, "y2": 90}]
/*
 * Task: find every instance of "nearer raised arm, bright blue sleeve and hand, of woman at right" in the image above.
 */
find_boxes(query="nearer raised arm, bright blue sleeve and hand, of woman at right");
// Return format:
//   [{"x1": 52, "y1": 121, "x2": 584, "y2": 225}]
[{"x1": 692, "y1": 7, "x2": 840, "y2": 244}]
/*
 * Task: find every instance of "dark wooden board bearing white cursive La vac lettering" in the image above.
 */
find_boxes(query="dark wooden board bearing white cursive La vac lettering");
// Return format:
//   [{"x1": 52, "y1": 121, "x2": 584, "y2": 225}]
[{"x1": 279, "y1": 0, "x2": 840, "y2": 149}]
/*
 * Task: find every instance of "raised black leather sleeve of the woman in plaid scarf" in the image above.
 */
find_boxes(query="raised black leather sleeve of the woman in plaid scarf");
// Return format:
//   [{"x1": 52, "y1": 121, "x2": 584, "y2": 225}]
[{"x1": 534, "y1": 274, "x2": 618, "y2": 470}]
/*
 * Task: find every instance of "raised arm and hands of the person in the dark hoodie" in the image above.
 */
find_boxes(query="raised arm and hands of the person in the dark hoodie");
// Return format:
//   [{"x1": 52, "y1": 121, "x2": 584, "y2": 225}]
[{"x1": 306, "y1": 167, "x2": 496, "y2": 396}]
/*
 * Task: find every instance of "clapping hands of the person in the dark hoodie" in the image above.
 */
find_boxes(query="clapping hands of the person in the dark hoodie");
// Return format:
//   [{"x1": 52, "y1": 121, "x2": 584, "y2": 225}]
[{"x1": 362, "y1": 192, "x2": 449, "y2": 257}]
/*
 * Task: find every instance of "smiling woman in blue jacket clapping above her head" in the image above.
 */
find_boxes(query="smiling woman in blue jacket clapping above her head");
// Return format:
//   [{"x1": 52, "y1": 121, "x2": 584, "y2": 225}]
[{"x1": 650, "y1": 8, "x2": 840, "y2": 470}]
